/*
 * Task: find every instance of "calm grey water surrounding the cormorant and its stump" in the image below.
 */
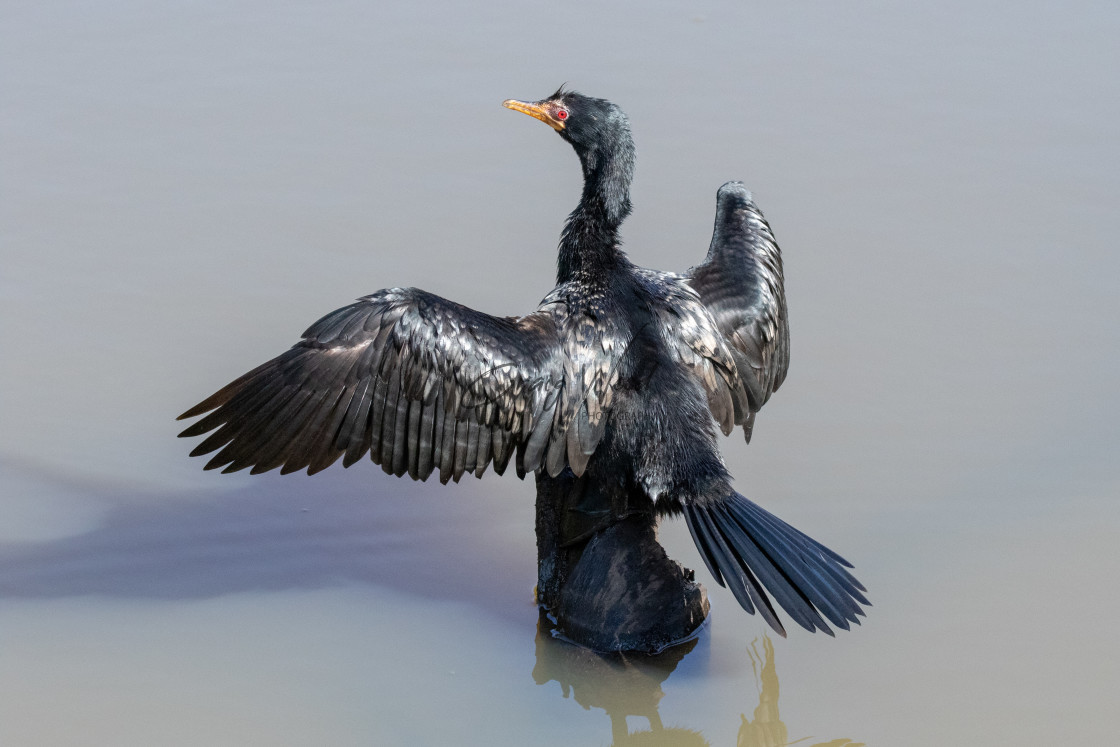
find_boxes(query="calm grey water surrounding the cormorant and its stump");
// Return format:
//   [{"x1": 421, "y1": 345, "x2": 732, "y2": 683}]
[{"x1": 0, "y1": 0, "x2": 1120, "y2": 747}]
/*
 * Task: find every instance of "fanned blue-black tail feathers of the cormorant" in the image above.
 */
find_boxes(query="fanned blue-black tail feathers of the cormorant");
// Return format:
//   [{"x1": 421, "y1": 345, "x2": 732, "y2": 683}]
[{"x1": 684, "y1": 492, "x2": 871, "y2": 636}]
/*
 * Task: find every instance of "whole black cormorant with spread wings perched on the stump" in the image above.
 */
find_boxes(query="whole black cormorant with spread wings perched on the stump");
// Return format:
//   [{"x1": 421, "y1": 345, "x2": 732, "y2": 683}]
[{"x1": 179, "y1": 88, "x2": 869, "y2": 635}]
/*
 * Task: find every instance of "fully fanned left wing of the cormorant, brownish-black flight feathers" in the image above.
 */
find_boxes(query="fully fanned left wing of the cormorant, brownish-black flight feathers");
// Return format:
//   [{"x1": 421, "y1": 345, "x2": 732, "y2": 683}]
[{"x1": 179, "y1": 288, "x2": 609, "y2": 483}]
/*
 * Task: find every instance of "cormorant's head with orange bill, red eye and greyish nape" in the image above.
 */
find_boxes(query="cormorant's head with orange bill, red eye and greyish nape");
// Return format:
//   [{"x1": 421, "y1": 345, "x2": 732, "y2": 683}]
[{"x1": 502, "y1": 87, "x2": 634, "y2": 222}]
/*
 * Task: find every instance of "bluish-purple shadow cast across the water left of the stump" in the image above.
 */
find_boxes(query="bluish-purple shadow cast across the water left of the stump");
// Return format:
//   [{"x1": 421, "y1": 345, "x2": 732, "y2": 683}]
[{"x1": 0, "y1": 457, "x2": 535, "y2": 620}]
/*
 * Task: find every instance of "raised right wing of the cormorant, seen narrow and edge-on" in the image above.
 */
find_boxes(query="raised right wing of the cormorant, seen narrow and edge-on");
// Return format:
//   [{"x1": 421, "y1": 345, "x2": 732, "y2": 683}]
[{"x1": 685, "y1": 181, "x2": 790, "y2": 441}]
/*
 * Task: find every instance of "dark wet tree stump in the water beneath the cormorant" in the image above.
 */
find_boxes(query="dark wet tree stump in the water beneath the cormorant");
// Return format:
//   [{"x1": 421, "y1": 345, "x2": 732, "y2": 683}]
[{"x1": 536, "y1": 470, "x2": 708, "y2": 652}]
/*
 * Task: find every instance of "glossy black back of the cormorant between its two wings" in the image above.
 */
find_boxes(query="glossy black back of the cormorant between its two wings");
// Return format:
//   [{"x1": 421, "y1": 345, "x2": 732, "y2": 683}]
[{"x1": 537, "y1": 257, "x2": 734, "y2": 511}]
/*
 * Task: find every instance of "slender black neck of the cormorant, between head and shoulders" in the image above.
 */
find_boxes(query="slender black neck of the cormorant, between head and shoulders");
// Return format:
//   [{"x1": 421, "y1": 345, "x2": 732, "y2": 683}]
[{"x1": 557, "y1": 151, "x2": 633, "y2": 283}]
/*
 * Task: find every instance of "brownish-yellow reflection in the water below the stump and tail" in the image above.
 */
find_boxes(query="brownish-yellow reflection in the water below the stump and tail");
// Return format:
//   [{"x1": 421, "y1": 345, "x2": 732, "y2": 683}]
[{"x1": 533, "y1": 614, "x2": 864, "y2": 747}]
